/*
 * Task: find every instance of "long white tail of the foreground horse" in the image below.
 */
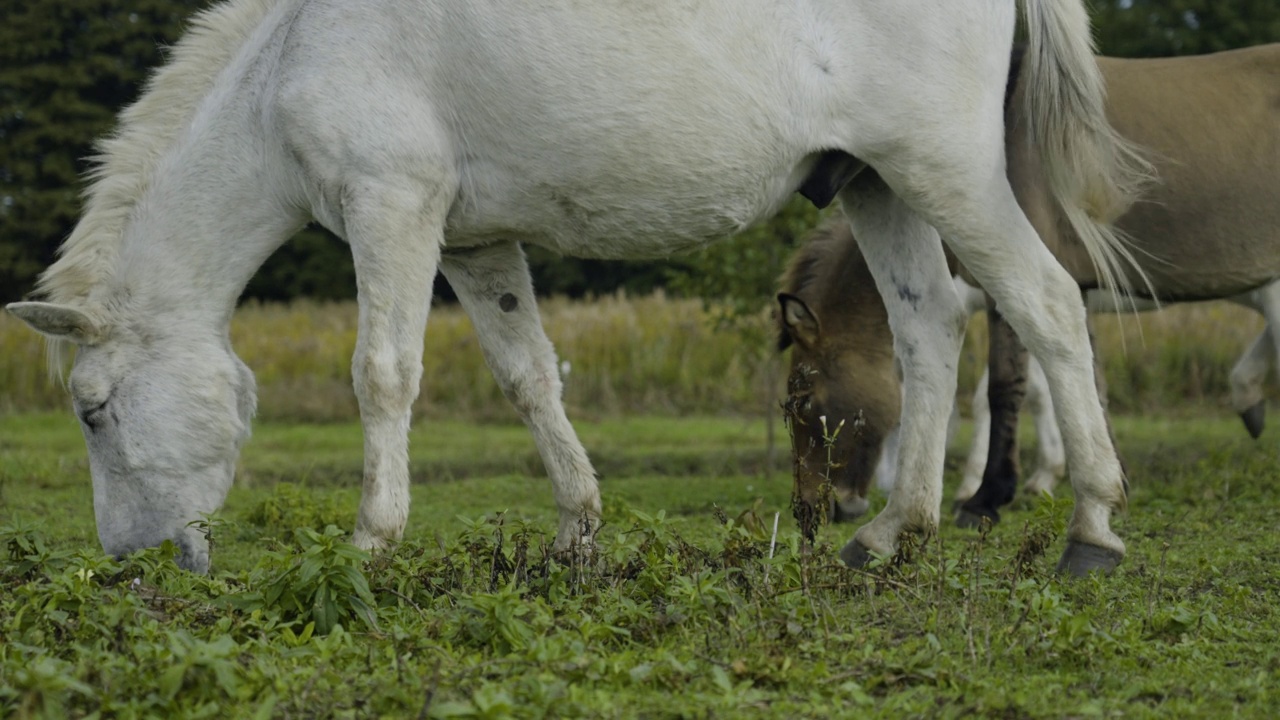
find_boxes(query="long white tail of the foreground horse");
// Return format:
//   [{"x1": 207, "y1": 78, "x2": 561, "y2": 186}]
[{"x1": 1021, "y1": 0, "x2": 1156, "y2": 306}]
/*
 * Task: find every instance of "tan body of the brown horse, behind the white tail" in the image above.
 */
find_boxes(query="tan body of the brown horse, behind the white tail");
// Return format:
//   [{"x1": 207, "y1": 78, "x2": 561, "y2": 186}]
[{"x1": 1024, "y1": 44, "x2": 1280, "y2": 294}]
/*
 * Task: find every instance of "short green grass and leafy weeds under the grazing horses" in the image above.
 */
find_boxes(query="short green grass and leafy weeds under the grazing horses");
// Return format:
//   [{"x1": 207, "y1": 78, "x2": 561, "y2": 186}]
[{"x1": 0, "y1": 413, "x2": 1280, "y2": 717}]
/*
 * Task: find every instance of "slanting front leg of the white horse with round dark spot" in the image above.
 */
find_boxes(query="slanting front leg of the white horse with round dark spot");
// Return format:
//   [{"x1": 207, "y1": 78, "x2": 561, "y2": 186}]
[{"x1": 440, "y1": 242, "x2": 600, "y2": 552}]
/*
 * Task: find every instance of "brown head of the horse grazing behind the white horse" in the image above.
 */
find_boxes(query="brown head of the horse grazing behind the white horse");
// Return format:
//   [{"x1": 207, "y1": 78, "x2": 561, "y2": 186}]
[{"x1": 778, "y1": 223, "x2": 901, "y2": 520}]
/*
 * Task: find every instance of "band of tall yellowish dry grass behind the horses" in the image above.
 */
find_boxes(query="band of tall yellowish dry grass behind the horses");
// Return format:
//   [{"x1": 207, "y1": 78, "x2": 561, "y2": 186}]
[{"x1": 0, "y1": 288, "x2": 1263, "y2": 421}]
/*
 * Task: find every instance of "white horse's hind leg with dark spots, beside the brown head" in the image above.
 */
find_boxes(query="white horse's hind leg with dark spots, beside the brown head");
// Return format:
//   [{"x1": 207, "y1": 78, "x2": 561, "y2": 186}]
[{"x1": 840, "y1": 178, "x2": 968, "y2": 566}]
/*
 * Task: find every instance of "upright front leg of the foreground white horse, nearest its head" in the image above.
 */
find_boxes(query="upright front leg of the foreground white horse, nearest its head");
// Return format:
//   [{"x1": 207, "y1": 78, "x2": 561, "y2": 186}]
[{"x1": 343, "y1": 181, "x2": 447, "y2": 550}]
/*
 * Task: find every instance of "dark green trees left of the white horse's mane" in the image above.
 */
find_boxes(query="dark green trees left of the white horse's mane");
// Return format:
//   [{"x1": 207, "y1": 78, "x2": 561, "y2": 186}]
[{"x1": 0, "y1": 0, "x2": 204, "y2": 301}]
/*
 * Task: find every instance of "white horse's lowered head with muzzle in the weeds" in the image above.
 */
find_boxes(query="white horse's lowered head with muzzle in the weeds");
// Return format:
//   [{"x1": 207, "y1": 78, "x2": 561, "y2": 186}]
[{"x1": 9, "y1": 302, "x2": 256, "y2": 573}]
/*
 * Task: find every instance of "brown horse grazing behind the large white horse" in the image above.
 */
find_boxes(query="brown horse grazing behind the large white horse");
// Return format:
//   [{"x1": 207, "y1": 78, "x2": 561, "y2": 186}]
[{"x1": 778, "y1": 45, "x2": 1280, "y2": 519}]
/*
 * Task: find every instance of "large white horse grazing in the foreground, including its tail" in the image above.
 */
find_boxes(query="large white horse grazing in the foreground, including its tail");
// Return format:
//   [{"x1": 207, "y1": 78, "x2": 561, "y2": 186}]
[{"x1": 9, "y1": 0, "x2": 1143, "y2": 573}]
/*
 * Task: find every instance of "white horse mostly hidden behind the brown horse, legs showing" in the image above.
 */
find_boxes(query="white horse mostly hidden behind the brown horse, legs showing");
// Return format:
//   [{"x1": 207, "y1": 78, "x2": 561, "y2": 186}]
[{"x1": 876, "y1": 275, "x2": 1280, "y2": 503}]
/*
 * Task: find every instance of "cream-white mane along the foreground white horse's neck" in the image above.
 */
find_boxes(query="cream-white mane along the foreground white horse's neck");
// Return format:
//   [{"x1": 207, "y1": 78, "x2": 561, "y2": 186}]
[{"x1": 33, "y1": 0, "x2": 282, "y2": 372}]
